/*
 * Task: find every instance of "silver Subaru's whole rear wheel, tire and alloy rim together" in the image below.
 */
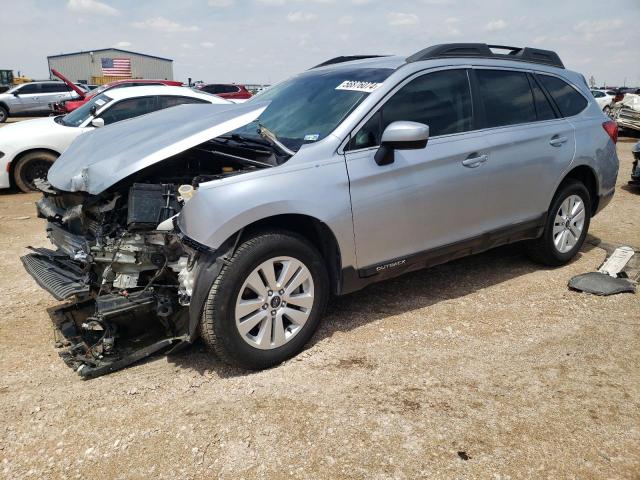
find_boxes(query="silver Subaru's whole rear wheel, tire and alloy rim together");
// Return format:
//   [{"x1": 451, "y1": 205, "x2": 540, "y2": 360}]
[{"x1": 527, "y1": 180, "x2": 591, "y2": 266}]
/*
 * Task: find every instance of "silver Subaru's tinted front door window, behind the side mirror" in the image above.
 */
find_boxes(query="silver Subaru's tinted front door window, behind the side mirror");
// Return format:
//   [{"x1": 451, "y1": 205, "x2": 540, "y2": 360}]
[{"x1": 349, "y1": 70, "x2": 473, "y2": 150}]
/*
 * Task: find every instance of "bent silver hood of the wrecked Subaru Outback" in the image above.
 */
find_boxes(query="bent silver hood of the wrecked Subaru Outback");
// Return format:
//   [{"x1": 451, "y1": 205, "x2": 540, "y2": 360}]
[{"x1": 48, "y1": 102, "x2": 268, "y2": 195}]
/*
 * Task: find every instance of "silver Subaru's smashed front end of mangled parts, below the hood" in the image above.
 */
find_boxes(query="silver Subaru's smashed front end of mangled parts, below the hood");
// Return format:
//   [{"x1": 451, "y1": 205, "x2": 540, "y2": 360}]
[{"x1": 22, "y1": 183, "x2": 188, "y2": 377}]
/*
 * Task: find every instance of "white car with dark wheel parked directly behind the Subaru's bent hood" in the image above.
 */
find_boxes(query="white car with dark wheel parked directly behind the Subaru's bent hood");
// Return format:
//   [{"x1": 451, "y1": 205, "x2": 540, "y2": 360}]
[{"x1": 0, "y1": 86, "x2": 230, "y2": 192}]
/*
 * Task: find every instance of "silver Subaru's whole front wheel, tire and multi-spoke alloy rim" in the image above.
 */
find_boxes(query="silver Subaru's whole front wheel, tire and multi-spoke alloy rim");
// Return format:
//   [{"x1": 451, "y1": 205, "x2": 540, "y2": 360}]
[{"x1": 200, "y1": 232, "x2": 329, "y2": 370}]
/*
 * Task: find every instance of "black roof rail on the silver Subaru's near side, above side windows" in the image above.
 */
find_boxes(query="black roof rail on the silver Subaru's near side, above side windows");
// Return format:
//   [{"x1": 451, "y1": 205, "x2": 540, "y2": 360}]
[{"x1": 407, "y1": 43, "x2": 564, "y2": 68}]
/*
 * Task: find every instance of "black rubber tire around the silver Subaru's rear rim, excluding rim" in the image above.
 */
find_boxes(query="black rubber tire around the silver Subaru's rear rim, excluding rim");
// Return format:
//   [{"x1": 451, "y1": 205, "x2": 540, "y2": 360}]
[{"x1": 526, "y1": 179, "x2": 591, "y2": 267}]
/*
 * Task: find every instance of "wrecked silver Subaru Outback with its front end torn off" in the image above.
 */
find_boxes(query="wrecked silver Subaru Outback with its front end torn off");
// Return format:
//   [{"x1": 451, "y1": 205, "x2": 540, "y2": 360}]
[{"x1": 22, "y1": 44, "x2": 618, "y2": 378}]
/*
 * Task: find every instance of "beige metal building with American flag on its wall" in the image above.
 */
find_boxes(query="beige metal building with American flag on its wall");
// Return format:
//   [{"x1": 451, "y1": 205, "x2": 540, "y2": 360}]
[{"x1": 47, "y1": 48, "x2": 173, "y2": 85}]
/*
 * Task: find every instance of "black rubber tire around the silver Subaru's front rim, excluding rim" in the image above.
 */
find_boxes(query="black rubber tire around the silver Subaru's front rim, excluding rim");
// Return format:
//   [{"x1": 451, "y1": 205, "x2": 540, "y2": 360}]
[{"x1": 200, "y1": 231, "x2": 329, "y2": 370}]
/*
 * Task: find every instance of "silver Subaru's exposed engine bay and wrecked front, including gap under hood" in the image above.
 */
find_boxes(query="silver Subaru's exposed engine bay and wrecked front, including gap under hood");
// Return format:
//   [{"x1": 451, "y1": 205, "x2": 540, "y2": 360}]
[{"x1": 22, "y1": 135, "x2": 288, "y2": 378}]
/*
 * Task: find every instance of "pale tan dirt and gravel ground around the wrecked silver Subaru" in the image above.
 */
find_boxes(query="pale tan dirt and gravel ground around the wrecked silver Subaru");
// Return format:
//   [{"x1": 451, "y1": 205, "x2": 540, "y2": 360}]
[{"x1": 0, "y1": 133, "x2": 640, "y2": 479}]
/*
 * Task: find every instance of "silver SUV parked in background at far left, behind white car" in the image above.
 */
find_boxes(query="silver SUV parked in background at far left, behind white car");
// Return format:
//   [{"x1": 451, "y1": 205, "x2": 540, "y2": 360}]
[{"x1": 0, "y1": 81, "x2": 80, "y2": 123}]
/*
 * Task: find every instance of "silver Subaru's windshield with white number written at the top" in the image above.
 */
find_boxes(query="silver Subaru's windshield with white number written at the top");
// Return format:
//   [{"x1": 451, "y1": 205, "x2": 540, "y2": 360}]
[{"x1": 232, "y1": 68, "x2": 393, "y2": 151}]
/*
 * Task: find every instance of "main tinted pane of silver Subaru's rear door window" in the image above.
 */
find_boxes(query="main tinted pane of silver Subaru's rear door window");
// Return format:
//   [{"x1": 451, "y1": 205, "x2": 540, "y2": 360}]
[{"x1": 476, "y1": 70, "x2": 537, "y2": 128}]
